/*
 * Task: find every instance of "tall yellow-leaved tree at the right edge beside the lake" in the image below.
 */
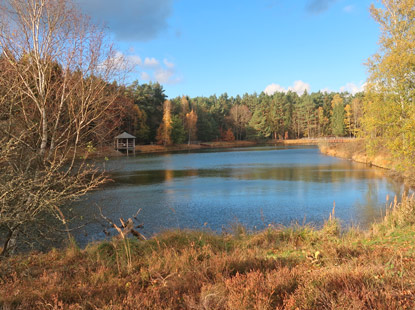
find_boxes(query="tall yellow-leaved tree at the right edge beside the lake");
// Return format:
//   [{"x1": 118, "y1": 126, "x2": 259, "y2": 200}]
[{"x1": 362, "y1": 0, "x2": 415, "y2": 168}]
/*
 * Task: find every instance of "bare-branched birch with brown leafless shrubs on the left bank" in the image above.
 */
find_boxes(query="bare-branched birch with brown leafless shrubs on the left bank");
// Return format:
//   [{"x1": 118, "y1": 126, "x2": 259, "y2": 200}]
[{"x1": 0, "y1": 0, "x2": 121, "y2": 255}]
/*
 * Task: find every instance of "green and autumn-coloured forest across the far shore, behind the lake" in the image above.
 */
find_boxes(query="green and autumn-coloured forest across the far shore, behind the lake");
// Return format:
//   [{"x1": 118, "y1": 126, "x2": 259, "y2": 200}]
[{"x1": 120, "y1": 81, "x2": 364, "y2": 145}]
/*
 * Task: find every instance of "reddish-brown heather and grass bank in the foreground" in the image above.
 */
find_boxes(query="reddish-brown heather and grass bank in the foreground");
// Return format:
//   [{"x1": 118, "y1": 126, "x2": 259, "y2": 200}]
[{"x1": 0, "y1": 199, "x2": 415, "y2": 309}]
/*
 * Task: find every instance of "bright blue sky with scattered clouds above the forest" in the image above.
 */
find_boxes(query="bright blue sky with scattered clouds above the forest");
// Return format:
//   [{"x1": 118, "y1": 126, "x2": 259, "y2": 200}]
[{"x1": 77, "y1": 0, "x2": 379, "y2": 98}]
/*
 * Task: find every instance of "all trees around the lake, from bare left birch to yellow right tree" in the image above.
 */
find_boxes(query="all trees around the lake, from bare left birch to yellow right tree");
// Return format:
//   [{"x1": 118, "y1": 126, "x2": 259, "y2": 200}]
[{"x1": 0, "y1": 0, "x2": 415, "y2": 256}]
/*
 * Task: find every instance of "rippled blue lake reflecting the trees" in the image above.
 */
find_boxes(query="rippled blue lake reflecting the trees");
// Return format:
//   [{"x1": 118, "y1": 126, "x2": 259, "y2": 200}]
[{"x1": 73, "y1": 146, "x2": 404, "y2": 245}]
